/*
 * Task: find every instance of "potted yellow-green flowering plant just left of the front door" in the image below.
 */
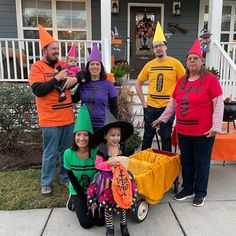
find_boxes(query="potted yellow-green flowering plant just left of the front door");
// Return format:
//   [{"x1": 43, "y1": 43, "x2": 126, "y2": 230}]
[{"x1": 111, "y1": 60, "x2": 131, "y2": 86}]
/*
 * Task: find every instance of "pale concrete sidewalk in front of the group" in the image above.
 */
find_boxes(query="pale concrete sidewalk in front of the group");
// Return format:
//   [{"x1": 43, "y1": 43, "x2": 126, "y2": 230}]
[{"x1": 0, "y1": 164, "x2": 236, "y2": 236}]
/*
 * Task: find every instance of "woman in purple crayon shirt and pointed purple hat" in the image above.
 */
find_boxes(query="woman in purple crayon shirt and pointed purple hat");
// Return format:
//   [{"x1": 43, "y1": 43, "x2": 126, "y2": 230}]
[{"x1": 72, "y1": 44, "x2": 118, "y2": 131}]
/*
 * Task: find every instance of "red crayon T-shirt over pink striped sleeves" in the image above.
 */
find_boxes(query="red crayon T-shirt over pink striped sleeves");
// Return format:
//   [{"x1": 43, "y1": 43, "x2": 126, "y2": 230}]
[{"x1": 173, "y1": 72, "x2": 222, "y2": 136}]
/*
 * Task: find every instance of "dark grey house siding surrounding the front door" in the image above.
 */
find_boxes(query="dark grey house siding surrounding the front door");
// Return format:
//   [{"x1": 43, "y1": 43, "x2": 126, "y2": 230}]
[{"x1": 111, "y1": 0, "x2": 199, "y2": 64}]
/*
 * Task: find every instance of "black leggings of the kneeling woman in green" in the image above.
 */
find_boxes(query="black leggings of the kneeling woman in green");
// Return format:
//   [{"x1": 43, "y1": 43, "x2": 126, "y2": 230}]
[{"x1": 71, "y1": 194, "x2": 106, "y2": 229}]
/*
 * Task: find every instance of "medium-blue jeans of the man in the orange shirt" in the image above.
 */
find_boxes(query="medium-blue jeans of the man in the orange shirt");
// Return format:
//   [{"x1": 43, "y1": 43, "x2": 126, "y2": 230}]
[{"x1": 41, "y1": 124, "x2": 74, "y2": 186}]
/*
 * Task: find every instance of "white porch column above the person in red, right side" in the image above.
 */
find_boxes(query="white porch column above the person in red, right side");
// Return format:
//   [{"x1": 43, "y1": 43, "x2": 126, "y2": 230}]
[{"x1": 206, "y1": 0, "x2": 223, "y2": 67}]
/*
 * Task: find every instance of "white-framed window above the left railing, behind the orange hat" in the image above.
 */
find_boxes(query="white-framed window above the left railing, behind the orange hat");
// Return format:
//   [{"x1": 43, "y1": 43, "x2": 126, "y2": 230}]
[{"x1": 21, "y1": 0, "x2": 88, "y2": 40}]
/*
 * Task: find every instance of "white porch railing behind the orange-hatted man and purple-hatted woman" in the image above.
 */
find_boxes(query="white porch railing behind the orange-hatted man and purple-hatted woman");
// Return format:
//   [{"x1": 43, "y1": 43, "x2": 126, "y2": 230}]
[{"x1": 0, "y1": 38, "x2": 103, "y2": 82}]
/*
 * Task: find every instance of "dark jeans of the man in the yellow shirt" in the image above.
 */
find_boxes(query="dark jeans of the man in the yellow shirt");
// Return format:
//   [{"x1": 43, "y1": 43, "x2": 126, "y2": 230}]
[{"x1": 142, "y1": 106, "x2": 175, "y2": 152}]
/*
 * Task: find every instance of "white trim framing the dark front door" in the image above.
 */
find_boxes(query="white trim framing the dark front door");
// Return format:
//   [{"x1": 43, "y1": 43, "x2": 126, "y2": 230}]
[{"x1": 127, "y1": 2, "x2": 164, "y2": 64}]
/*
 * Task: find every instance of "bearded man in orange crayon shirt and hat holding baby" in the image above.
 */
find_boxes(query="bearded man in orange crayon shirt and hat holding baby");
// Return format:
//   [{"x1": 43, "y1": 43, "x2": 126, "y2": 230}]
[{"x1": 29, "y1": 26, "x2": 77, "y2": 196}]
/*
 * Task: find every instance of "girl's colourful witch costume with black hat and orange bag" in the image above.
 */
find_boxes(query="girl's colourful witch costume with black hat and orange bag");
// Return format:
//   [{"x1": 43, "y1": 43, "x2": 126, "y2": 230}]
[{"x1": 87, "y1": 110, "x2": 138, "y2": 236}]
